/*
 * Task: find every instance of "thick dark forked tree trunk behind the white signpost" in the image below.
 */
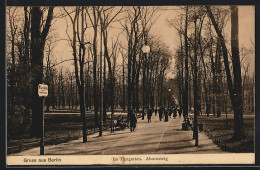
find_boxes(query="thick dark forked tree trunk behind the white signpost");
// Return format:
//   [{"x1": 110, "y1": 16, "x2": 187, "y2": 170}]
[{"x1": 31, "y1": 7, "x2": 53, "y2": 137}]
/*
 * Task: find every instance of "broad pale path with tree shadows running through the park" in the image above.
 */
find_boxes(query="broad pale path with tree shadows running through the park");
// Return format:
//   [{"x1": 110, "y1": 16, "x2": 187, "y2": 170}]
[{"x1": 13, "y1": 114, "x2": 224, "y2": 155}]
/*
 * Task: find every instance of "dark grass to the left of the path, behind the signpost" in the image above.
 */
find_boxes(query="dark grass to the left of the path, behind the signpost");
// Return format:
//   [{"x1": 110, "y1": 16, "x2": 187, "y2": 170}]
[{"x1": 7, "y1": 114, "x2": 127, "y2": 154}]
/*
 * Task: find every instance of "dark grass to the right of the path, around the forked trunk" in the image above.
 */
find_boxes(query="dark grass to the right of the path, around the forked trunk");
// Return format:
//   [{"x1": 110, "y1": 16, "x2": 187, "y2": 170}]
[{"x1": 198, "y1": 113, "x2": 255, "y2": 153}]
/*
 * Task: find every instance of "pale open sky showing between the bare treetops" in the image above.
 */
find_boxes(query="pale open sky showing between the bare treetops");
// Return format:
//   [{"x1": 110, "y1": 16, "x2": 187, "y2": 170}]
[{"x1": 8, "y1": 6, "x2": 255, "y2": 78}]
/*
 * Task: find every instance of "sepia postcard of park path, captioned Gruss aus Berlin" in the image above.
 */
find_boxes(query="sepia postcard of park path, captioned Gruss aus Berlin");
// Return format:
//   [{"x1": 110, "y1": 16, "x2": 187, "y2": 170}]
[{"x1": 5, "y1": 5, "x2": 255, "y2": 166}]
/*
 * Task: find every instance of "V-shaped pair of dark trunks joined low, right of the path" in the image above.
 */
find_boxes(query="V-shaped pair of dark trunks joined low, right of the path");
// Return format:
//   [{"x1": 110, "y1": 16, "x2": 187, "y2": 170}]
[{"x1": 206, "y1": 6, "x2": 244, "y2": 140}]
